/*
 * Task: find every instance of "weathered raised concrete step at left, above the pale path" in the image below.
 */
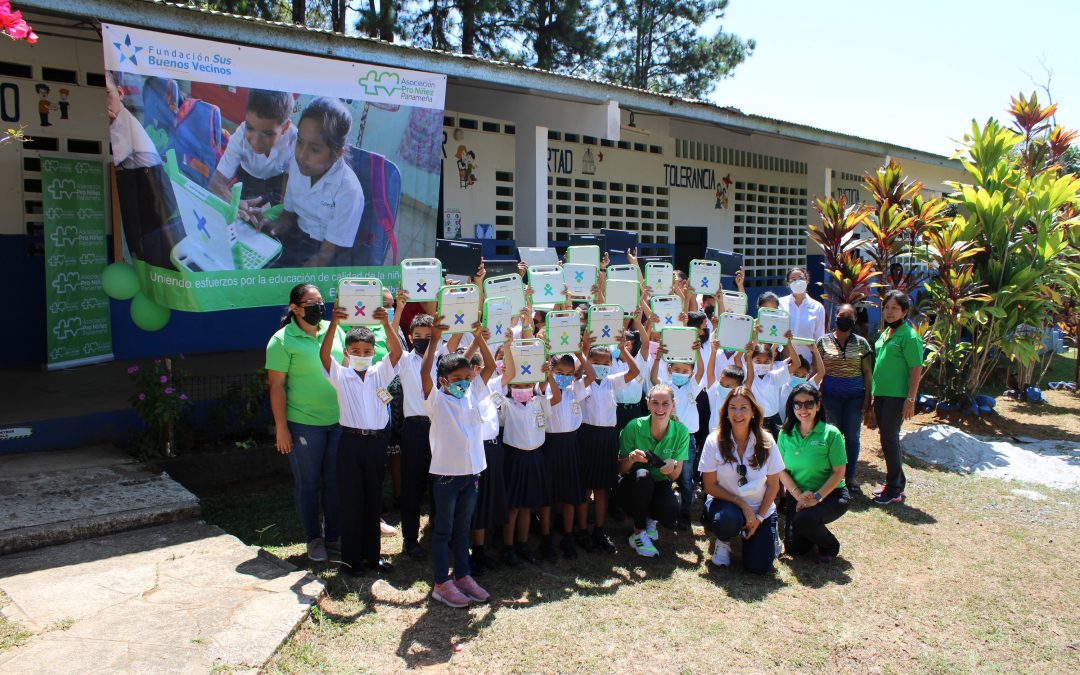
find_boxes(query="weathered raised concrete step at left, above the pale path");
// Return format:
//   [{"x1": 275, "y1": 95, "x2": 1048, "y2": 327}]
[{"x1": 0, "y1": 446, "x2": 200, "y2": 555}]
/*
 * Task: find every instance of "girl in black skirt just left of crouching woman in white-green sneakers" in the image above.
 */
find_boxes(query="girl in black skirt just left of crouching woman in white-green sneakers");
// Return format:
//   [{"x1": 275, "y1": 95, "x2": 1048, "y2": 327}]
[{"x1": 575, "y1": 341, "x2": 640, "y2": 553}]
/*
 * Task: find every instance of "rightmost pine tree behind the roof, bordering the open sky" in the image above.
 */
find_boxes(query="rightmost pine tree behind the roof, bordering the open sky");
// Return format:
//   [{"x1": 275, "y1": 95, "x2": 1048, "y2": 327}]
[{"x1": 599, "y1": 0, "x2": 755, "y2": 99}]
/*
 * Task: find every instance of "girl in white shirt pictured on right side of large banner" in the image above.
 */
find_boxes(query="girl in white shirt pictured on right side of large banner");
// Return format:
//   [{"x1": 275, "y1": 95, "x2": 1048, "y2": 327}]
[{"x1": 271, "y1": 98, "x2": 364, "y2": 267}]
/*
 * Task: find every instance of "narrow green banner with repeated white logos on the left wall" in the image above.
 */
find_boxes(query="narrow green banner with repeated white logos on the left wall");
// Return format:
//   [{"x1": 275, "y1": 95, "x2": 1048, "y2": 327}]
[{"x1": 41, "y1": 156, "x2": 112, "y2": 369}]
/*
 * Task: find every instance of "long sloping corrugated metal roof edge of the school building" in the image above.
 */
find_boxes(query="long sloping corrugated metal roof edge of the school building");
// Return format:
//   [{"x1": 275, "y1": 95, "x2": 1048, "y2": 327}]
[{"x1": 19, "y1": 0, "x2": 960, "y2": 168}]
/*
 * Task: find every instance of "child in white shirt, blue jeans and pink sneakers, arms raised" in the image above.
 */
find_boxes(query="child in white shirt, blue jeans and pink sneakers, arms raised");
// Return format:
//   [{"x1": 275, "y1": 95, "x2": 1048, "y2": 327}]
[{"x1": 420, "y1": 316, "x2": 495, "y2": 607}]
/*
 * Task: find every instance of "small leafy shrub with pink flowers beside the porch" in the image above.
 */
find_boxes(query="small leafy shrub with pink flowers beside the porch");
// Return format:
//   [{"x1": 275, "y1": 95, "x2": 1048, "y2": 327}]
[{"x1": 127, "y1": 359, "x2": 191, "y2": 459}]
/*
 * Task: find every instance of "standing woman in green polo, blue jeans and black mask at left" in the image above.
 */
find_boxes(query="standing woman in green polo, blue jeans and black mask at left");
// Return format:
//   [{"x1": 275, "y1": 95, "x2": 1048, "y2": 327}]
[{"x1": 267, "y1": 284, "x2": 345, "y2": 563}]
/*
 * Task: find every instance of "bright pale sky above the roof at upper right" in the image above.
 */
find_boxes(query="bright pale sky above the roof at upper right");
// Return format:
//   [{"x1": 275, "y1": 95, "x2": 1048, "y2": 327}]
[{"x1": 712, "y1": 0, "x2": 1080, "y2": 154}]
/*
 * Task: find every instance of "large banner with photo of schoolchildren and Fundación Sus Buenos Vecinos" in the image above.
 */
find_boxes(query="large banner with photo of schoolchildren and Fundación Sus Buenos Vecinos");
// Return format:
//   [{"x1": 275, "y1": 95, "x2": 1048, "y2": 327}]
[{"x1": 102, "y1": 24, "x2": 446, "y2": 311}]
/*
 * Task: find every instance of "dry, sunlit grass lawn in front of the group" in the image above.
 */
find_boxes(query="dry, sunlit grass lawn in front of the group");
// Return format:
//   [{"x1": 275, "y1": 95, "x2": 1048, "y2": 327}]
[{"x1": 196, "y1": 392, "x2": 1080, "y2": 673}]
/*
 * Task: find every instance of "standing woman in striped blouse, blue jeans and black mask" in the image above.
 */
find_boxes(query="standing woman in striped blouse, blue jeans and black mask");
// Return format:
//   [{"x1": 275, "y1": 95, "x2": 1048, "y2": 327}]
[{"x1": 818, "y1": 305, "x2": 873, "y2": 491}]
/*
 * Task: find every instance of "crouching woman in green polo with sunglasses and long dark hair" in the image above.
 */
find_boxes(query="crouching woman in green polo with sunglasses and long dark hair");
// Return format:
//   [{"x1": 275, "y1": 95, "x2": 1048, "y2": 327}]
[{"x1": 777, "y1": 383, "x2": 851, "y2": 563}]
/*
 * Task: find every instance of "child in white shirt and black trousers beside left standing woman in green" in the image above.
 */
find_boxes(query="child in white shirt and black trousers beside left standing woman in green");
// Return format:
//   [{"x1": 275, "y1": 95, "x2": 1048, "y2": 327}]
[{"x1": 319, "y1": 307, "x2": 402, "y2": 576}]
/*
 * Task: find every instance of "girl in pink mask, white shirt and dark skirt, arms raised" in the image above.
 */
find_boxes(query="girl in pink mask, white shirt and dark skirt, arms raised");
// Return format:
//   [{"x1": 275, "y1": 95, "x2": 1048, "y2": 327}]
[{"x1": 502, "y1": 356, "x2": 563, "y2": 567}]
